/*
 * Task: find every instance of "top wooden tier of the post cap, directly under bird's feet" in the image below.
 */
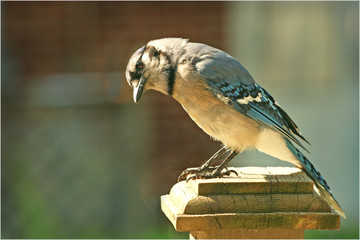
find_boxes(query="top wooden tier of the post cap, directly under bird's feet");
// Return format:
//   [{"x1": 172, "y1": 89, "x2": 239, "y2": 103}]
[{"x1": 188, "y1": 167, "x2": 314, "y2": 195}]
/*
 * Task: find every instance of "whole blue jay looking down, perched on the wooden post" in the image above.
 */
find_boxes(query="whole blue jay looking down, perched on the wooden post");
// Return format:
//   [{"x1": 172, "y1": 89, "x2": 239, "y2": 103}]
[{"x1": 126, "y1": 38, "x2": 345, "y2": 218}]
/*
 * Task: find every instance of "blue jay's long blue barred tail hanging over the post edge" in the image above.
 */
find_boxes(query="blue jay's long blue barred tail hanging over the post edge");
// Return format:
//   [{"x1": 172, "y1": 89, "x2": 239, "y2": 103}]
[{"x1": 286, "y1": 140, "x2": 346, "y2": 218}]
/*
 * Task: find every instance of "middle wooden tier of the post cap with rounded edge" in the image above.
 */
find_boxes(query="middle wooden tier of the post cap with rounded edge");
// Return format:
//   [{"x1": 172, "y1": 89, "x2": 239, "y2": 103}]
[{"x1": 170, "y1": 181, "x2": 331, "y2": 214}]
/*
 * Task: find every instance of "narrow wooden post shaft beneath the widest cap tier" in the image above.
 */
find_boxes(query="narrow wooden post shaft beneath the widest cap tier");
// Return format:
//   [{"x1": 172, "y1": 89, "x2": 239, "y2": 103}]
[{"x1": 190, "y1": 229, "x2": 304, "y2": 239}]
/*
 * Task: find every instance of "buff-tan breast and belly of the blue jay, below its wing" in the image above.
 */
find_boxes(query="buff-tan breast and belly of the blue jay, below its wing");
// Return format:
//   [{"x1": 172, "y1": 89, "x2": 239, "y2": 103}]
[{"x1": 173, "y1": 76, "x2": 260, "y2": 152}]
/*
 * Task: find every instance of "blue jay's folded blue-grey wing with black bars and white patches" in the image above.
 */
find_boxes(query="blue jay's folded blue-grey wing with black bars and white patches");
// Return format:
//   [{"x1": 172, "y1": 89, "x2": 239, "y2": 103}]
[{"x1": 193, "y1": 48, "x2": 308, "y2": 151}]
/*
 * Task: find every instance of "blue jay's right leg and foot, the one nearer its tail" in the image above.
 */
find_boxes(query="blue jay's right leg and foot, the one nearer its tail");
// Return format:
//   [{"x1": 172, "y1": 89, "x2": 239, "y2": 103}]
[{"x1": 186, "y1": 151, "x2": 238, "y2": 181}]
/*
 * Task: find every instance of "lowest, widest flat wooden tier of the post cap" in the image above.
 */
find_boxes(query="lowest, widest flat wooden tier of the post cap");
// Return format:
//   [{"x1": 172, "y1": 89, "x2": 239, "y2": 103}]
[{"x1": 161, "y1": 195, "x2": 340, "y2": 232}]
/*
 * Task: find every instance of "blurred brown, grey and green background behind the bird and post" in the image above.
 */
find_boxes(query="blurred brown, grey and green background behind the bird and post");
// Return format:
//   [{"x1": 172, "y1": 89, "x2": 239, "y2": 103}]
[{"x1": 1, "y1": 2, "x2": 359, "y2": 238}]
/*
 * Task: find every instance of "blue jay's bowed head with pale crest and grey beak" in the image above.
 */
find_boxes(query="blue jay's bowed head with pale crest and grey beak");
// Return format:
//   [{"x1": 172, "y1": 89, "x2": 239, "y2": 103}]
[{"x1": 126, "y1": 38, "x2": 188, "y2": 103}]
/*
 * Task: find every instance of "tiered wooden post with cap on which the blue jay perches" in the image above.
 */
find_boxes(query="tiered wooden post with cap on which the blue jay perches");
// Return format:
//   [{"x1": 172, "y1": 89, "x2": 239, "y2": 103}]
[{"x1": 161, "y1": 167, "x2": 340, "y2": 239}]
